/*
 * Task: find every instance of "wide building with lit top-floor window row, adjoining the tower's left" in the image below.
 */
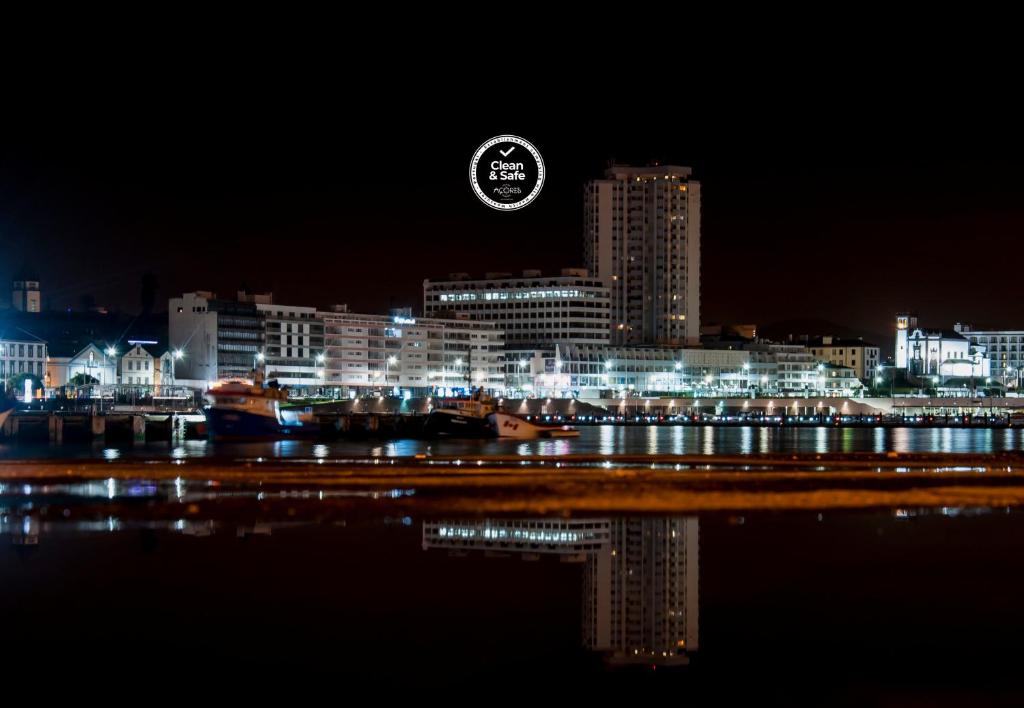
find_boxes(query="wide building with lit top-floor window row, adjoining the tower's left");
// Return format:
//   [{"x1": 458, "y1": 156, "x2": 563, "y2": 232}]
[{"x1": 423, "y1": 268, "x2": 611, "y2": 356}]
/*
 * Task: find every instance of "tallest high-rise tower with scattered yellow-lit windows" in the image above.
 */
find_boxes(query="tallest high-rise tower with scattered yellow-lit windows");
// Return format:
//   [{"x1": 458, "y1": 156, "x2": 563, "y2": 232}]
[{"x1": 584, "y1": 165, "x2": 700, "y2": 345}]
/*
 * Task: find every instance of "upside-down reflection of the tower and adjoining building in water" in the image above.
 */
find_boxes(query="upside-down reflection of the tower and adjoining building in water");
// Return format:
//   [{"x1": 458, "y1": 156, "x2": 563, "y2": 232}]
[{"x1": 423, "y1": 516, "x2": 699, "y2": 666}]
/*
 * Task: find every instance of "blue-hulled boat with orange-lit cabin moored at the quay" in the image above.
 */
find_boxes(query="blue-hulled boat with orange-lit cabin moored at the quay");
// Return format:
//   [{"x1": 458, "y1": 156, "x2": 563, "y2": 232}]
[{"x1": 203, "y1": 370, "x2": 311, "y2": 441}]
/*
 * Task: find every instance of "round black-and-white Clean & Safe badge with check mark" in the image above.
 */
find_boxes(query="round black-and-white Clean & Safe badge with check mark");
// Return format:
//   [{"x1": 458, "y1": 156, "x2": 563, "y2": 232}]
[{"x1": 469, "y1": 135, "x2": 545, "y2": 211}]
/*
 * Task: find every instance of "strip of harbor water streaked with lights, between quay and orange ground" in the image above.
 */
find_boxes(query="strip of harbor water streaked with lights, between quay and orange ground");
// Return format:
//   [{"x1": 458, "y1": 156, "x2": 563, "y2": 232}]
[{"x1": 6, "y1": 425, "x2": 1024, "y2": 460}]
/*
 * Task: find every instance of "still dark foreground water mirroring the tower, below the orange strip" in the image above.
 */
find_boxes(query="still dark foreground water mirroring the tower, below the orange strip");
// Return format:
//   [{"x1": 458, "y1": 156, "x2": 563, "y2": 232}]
[{"x1": 0, "y1": 497, "x2": 1024, "y2": 706}]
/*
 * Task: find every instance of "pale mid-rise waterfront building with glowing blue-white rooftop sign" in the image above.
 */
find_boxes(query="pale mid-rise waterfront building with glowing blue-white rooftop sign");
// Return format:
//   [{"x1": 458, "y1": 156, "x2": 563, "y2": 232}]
[{"x1": 317, "y1": 310, "x2": 505, "y2": 395}]
